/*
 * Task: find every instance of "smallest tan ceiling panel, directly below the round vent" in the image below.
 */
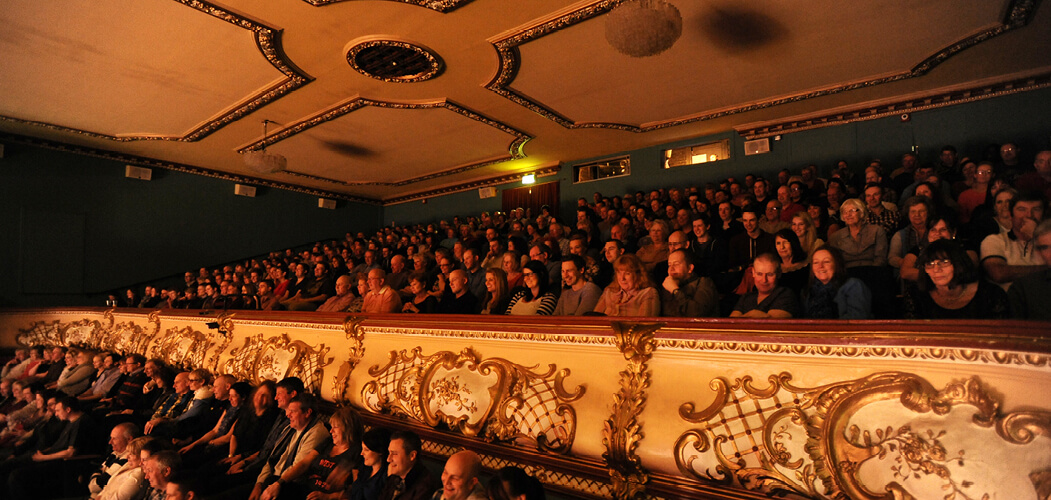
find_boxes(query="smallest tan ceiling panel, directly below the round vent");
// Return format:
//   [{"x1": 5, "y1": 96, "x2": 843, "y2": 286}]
[{"x1": 259, "y1": 100, "x2": 524, "y2": 185}]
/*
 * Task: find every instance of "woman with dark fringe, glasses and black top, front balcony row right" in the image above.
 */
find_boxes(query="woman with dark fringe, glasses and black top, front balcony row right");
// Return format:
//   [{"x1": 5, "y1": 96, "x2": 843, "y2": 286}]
[{"x1": 905, "y1": 239, "x2": 1010, "y2": 319}]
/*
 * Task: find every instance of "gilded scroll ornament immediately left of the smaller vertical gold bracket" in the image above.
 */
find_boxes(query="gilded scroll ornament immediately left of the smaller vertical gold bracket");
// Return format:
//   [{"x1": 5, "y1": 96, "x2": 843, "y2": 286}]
[{"x1": 223, "y1": 333, "x2": 332, "y2": 392}]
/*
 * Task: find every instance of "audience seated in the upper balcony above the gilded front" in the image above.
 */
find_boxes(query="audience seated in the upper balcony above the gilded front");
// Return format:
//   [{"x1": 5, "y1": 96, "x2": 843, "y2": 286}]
[{"x1": 111, "y1": 144, "x2": 1051, "y2": 319}]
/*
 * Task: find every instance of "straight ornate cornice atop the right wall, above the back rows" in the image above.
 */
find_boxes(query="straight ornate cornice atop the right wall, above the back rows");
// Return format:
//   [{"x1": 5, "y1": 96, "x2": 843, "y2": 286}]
[{"x1": 734, "y1": 71, "x2": 1051, "y2": 141}]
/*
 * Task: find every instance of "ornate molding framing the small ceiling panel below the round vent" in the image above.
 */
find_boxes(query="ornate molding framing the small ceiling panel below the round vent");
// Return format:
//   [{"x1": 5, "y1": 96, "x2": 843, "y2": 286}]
[{"x1": 238, "y1": 98, "x2": 533, "y2": 183}]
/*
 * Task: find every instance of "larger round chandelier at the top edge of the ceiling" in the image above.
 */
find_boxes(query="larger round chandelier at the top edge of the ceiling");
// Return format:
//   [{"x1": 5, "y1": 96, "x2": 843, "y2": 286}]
[{"x1": 605, "y1": 0, "x2": 682, "y2": 58}]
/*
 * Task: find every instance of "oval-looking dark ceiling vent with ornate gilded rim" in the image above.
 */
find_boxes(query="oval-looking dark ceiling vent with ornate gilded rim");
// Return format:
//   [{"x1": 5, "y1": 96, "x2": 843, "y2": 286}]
[{"x1": 347, "y1": 40, "x2": 444, "y2": 83}]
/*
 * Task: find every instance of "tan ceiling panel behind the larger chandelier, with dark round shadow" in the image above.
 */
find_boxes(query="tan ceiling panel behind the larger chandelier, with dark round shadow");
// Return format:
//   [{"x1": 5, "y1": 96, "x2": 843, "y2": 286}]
[{"x1": 509, "y1": 0, "x2": 1005, "y2": 126}]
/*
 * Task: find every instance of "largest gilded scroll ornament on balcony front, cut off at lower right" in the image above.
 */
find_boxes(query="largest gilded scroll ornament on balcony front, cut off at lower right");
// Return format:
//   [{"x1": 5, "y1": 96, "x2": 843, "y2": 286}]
[{"x1": 675, "y1": 372, "x2": 1051, "y2": 500}]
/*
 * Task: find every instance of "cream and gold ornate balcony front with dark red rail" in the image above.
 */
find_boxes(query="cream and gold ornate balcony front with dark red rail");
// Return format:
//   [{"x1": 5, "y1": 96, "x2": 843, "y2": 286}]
[{"x1": 0, "y1": 308, "x2": 1051, "y2": 499}]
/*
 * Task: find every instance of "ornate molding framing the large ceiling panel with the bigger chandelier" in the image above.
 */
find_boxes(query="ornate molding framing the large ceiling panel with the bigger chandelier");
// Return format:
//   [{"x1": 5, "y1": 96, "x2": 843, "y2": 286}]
[{"x1": 486, "y1": 0, "x2": 1039, "y2": 132}]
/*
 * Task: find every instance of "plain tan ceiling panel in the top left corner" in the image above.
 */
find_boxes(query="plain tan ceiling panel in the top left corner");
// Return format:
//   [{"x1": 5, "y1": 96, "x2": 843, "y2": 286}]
[{"x1": 0, "y1": 0, "x2": 285, "y2": 138}]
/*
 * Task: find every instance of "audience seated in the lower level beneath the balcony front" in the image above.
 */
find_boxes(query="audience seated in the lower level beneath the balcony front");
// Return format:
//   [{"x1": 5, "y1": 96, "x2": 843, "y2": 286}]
[{"x1": 0, "y1": 347, "x2": 544, "y2": 500}]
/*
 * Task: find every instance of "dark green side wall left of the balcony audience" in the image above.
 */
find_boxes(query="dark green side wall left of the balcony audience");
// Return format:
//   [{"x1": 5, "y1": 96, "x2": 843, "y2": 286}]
[{"x1": 0, "y1": 144, "x2": 382, "y2": 306}]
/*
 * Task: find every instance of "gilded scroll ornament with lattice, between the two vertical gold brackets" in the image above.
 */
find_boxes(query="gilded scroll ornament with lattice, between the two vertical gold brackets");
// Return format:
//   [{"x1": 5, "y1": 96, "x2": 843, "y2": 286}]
[{"x1": 362, "y1": 347, "x2": 584, "y2": 454}]
